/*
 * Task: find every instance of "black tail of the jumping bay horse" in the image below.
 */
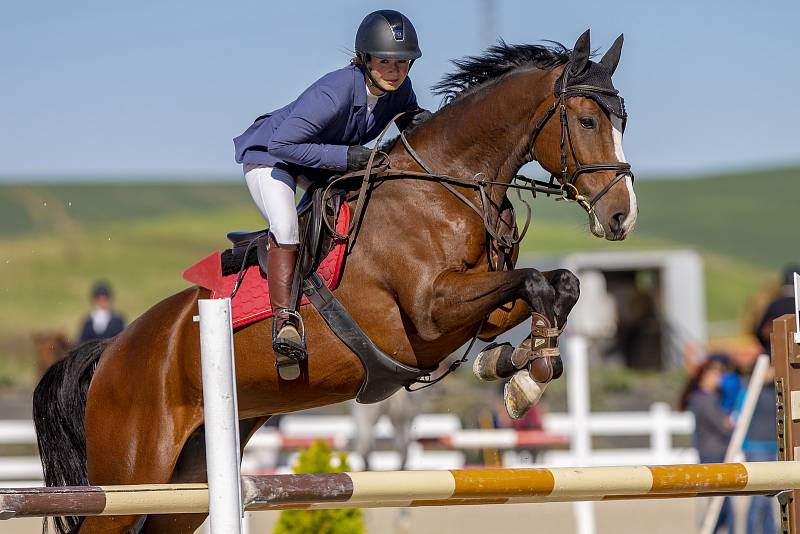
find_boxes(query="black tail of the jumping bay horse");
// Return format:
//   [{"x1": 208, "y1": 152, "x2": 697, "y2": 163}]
[{"x1": 33, "y1": 341, "x2": 108, "y2": 534}]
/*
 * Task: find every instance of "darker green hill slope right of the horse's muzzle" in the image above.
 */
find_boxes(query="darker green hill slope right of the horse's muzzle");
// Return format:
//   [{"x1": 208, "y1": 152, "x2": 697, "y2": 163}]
[{"x1": 532, "y1": 167, "x2": 800, "y2": 269}]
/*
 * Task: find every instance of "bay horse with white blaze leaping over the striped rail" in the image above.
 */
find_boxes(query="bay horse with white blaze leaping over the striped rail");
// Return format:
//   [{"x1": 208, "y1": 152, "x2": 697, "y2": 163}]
[{"x1": 34, "y1": 31, "x2": 638, "y2": 534}]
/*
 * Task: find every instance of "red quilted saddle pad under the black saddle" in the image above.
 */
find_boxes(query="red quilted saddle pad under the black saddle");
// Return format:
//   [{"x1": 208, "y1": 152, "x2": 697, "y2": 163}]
[{"x1": 183, "y1": 204, "x2": 350, "y2": 328}]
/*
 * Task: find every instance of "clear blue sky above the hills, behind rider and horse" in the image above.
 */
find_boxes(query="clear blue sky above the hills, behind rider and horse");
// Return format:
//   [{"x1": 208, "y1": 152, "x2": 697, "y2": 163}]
[{"x1": 0, "y1": 0, "x2": 800, "y2": 182}]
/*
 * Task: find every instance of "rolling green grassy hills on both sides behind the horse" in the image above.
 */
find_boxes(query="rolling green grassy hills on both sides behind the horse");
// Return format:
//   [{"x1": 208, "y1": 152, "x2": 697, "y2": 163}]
[{"x1": 0, "y1": 169, "x2": 800, "y2": 386}]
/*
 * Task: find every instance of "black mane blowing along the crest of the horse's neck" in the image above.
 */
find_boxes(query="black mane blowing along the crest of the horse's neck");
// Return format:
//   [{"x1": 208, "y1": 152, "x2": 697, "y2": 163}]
[{"x1": 431, "y1": 39, "x2": 572, "y2": 105}]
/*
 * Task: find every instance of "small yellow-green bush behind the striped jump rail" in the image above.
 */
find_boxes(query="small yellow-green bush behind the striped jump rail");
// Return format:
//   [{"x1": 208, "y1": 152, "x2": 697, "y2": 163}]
[{"x1": 274, "y1": 440, "x2": 364, "y2": 534}]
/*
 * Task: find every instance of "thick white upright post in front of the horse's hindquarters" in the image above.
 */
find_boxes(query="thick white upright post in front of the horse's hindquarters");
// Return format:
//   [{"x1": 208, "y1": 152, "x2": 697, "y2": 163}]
[{"x1": 198, "y1": 299, "x2": 242, "y2": 534}]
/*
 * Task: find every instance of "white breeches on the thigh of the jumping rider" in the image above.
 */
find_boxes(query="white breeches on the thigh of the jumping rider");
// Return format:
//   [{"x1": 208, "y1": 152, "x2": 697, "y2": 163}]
[{"x1": 244, "y1": 163, "x2": 308, "y2": 245}]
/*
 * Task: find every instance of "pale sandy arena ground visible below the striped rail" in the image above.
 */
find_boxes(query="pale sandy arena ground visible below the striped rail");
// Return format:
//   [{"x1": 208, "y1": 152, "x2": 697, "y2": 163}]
[{"x1": 0, "y1": 497, "x2": 768, "y2": 534}]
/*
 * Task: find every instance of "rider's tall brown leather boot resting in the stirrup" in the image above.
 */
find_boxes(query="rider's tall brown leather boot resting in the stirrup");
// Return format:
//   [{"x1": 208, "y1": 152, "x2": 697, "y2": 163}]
[{"x1": 267, "y1": 238, "x2": 306, "y2": 380}]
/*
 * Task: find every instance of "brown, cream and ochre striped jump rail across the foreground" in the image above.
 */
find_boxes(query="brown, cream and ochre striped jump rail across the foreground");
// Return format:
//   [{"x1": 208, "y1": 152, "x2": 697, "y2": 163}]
[{"x1": 0, "y1": 462, "x2": 800, "y2": 519}]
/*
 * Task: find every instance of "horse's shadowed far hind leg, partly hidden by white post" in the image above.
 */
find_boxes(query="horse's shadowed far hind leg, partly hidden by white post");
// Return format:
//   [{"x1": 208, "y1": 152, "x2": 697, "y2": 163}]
[{"x1": 140, "y1": 417, "x2": 269, "y2": 534}]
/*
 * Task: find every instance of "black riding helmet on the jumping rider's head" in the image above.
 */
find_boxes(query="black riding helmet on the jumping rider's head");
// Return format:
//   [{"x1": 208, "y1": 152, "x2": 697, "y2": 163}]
[{"x1": 355, "y1": 9, "x2": 422, "y2": 64}]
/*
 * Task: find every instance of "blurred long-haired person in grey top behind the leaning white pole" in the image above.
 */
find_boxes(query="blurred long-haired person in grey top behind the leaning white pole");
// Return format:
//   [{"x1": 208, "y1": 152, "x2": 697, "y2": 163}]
[{"x1": 680, "y1": 358, "x2": 736, "y2": 534}]
